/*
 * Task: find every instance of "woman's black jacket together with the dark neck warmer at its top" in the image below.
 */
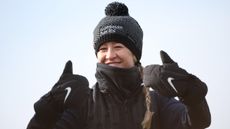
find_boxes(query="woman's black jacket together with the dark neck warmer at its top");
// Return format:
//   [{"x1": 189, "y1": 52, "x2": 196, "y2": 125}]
[{"x1": 28, "y1": 64, "x2": 210, "y2": 129}]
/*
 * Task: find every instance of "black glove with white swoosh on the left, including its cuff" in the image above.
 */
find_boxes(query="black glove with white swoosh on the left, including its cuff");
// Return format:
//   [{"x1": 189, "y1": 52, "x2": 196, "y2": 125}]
[{"x1": 34, "y1": 61, "x2": 89, "y2": 123}]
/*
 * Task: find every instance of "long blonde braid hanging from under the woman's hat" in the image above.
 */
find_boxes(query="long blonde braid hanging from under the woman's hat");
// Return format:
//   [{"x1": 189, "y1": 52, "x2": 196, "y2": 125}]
[{"x1": 137, "y1": 62, "x2": 154, "y2": 129}]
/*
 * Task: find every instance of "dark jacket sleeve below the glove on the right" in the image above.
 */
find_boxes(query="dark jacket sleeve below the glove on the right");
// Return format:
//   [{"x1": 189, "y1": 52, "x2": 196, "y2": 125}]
[{"x1": 157, "y1": 94, "x2": 210, "y2": 129}]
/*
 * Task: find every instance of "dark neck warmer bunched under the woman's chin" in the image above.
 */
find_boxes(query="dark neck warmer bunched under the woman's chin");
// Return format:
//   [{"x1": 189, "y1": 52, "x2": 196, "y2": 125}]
[{"x1": 95, "y1": 63, "x2": 142, "y2": 99}]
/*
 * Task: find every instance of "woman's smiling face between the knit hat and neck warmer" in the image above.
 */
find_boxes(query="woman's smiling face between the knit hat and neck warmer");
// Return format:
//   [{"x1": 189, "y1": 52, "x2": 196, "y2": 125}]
[{"x1": 97, "y1": 42, "x2": 135, "y2": 68}]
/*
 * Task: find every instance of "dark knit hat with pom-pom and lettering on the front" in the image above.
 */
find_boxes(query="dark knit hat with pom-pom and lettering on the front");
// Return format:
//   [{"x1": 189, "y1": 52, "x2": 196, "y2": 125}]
[{"x1": 94, "y1": 2, "x2": 143, "y2": 62}]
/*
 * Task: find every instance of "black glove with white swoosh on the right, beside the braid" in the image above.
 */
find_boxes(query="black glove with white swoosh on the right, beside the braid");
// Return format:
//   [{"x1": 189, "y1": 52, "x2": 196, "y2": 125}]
[{"x1": 143, "y1": 51, "x2": 207, "y2": 104}]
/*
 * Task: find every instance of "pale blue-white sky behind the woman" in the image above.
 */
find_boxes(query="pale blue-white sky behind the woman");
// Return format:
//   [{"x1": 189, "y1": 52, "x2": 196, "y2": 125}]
[{"x1": 0, "y1": 0, "x2": 230, "y2": 129}]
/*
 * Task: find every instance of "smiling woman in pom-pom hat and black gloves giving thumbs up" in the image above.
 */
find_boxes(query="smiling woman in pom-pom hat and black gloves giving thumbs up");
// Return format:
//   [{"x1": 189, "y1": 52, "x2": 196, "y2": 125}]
[{"x1": 27, "y1": 2, "x2": 210, "y2": 129}]
